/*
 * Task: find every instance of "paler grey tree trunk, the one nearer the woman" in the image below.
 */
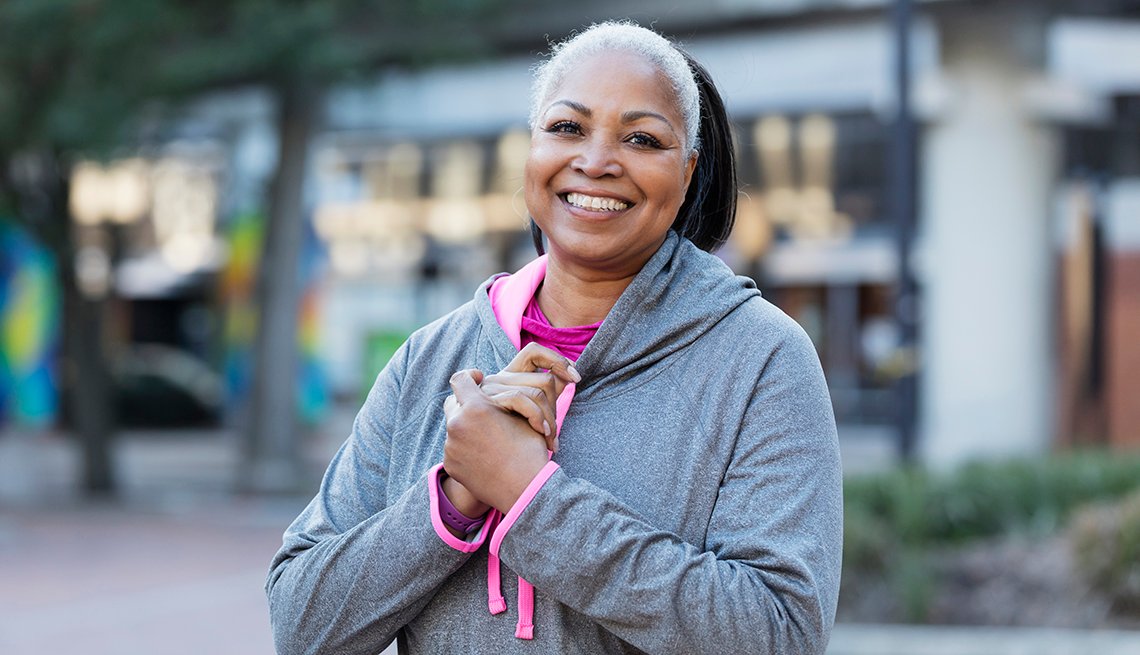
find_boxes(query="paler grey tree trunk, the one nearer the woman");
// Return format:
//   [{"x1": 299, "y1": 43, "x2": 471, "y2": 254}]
[{"x1": 242, "y1": 82, "x2": 320, "y2": 493}]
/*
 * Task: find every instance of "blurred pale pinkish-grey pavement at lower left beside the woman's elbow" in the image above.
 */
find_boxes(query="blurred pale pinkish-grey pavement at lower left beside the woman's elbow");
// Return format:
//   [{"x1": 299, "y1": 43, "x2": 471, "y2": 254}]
[{"x1": 0, "y1": 500, "x2": 298, "y2": 655}]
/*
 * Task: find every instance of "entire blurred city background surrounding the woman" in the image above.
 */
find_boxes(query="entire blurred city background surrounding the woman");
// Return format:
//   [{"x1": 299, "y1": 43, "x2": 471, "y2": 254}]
[{"x1": 0, "y1": 0, "x2": 1140, "y2": 653}]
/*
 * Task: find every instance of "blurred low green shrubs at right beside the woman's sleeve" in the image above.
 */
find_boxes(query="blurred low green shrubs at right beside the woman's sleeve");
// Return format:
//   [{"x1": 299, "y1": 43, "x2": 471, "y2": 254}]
[{"x1": 844, "y1": 452, "x2": 1140, "y2": 622}]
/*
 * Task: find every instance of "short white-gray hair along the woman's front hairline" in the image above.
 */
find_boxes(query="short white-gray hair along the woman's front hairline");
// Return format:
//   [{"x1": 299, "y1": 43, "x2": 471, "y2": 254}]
[{"x1": 530, "y1": 22, "x2": 701, "y2": 150}]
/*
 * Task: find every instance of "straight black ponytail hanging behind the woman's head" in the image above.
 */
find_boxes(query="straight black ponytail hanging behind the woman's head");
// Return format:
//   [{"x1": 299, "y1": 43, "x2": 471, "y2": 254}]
[{"x1": 673, "y1": 48, "x2": 736, "y2": 252}]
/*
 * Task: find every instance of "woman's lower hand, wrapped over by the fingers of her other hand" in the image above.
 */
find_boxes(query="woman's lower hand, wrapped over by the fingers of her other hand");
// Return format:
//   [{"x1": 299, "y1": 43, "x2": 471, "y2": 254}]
[{"x1": 443, "y1": 370, "x2": 547, "y2": 516}]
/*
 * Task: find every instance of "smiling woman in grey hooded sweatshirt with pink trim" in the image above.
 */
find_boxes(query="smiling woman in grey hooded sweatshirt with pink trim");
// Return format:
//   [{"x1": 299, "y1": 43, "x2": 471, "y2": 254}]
[{"x1": 267, "y1": 23, "x2": 842, "y2": 653}]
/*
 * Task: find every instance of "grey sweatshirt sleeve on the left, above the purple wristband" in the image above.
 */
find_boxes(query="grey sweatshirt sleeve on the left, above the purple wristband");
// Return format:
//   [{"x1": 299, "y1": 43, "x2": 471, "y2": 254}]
[{"x1": 266, "y1": 346, "x2": 483, "y2": 654}]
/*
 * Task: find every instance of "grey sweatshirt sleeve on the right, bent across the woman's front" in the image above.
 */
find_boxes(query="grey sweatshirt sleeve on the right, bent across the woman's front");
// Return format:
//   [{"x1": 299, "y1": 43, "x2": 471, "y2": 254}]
[{"x1": 492, "y1": 328, "x2": 842, "y2": 654}]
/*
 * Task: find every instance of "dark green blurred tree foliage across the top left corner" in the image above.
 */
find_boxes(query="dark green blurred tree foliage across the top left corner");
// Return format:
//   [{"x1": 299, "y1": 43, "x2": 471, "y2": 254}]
[{"x1": 0, "y1": 0, "x2": 513, "y2": 162}]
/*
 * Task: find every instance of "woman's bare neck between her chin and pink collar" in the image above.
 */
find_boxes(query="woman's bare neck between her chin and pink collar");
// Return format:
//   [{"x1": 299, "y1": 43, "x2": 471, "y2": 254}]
[{"x1": 538, "y1": 256, "x2": 637, "y2": 327}]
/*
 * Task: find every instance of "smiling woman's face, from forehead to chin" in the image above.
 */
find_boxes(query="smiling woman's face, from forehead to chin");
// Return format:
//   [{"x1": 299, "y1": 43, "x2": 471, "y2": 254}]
[{"x1": 526, "y1": 51, "x2": 697, "y2": 275}]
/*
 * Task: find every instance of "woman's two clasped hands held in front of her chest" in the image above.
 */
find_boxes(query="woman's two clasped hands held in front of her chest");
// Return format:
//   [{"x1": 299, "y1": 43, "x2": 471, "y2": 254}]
[{"x1": 443, "y1": 343, "x2": 581, "y2": 524}]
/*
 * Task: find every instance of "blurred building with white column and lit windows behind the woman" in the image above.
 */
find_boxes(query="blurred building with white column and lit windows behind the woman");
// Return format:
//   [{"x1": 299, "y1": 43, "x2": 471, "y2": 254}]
[{"x1": 86, "y1": 0, "x2": 1140, "y2": 466}]
